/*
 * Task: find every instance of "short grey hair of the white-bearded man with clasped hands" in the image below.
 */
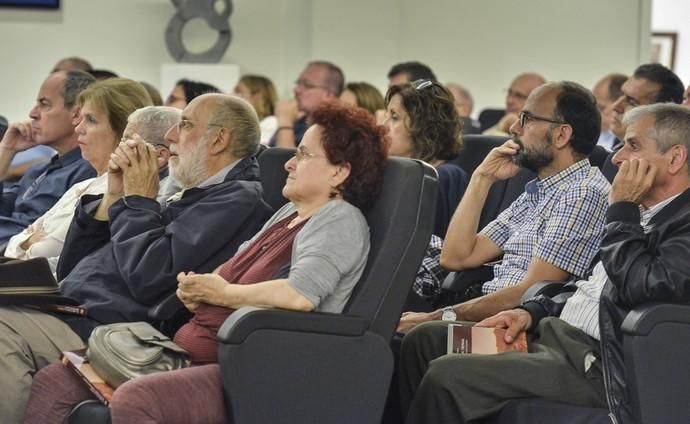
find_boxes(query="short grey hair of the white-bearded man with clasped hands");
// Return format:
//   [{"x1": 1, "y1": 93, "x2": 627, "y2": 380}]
[{"x1": 206, "y1": 94, "x2": 261, "y2": 159}]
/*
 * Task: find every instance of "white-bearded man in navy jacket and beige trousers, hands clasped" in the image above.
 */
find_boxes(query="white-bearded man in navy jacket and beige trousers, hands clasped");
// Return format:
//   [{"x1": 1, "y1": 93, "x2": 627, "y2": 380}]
[{"x1": 0, "y1": 94, "x2": 269, "y2": 422}]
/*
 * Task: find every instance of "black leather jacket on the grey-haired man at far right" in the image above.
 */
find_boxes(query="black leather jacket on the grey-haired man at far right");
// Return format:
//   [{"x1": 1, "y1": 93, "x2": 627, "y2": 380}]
[{"x1": 522, "y1": 190, "x2": 690, "y2": 423}]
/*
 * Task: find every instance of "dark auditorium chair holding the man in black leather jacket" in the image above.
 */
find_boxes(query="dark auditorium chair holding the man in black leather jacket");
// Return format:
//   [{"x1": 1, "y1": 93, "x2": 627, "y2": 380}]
[{"x1": 485, "y1": 283, "x2": 690, "y2": 424}]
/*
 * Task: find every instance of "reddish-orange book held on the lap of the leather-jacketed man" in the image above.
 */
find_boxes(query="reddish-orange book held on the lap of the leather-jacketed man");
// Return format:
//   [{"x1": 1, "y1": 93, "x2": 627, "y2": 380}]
[{"x1": 448, "y1": 323, "x2": 527, "y2": 354}]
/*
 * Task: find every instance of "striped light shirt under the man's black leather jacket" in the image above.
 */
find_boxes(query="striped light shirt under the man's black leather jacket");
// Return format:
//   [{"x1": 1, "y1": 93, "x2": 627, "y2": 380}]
[{"x1": 561, "y1": 195, "x2": 678, "y2": 340}]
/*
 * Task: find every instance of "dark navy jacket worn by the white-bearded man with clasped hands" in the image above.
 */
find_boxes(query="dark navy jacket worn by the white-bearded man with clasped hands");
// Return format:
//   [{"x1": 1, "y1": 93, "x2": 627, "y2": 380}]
[{"x1": 58, "y1": 158, "x2": 272, "y2": 338}]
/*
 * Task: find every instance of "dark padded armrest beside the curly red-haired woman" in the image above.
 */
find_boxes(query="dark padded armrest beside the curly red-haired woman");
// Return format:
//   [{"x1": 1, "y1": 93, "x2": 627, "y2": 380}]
[{"x1": 218, "y1": 306, "x2": 367, "y2": 344}]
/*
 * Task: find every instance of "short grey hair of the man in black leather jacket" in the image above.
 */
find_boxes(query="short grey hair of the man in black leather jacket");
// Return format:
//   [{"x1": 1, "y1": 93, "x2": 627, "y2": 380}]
[{"x1": 623, "y1": 103, "x2": 690, "y2": 153}]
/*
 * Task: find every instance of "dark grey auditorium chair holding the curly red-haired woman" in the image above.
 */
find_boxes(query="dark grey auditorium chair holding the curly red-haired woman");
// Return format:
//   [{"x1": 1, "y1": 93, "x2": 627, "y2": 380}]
[{"x1": 69, "y1": 157, "x2": 438, "y2": 424}]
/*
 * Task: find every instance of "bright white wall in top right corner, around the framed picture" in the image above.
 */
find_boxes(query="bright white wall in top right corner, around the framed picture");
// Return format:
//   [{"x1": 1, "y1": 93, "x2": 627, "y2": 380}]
[{"x1": 652, "y1": 0, "x2": 690, "y2": 86}]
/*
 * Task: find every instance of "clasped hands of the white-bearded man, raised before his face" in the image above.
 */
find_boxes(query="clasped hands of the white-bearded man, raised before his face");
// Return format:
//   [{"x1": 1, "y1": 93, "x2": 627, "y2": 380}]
[{"x1": 108, "y1": 134, "x2": 159, "y2": 199}]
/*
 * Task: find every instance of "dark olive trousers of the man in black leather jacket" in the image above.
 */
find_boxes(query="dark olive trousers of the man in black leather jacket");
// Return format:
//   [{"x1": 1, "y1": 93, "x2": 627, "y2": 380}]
[{"x1": 399, "y1": 318, "x2": 606, "y2": 424}]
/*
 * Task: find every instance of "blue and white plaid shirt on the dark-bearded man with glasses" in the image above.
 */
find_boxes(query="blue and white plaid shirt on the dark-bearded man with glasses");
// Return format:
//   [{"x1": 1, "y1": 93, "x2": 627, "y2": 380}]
[{"x1": 480, "y1": 159, "x2": 611, "y2": 293}]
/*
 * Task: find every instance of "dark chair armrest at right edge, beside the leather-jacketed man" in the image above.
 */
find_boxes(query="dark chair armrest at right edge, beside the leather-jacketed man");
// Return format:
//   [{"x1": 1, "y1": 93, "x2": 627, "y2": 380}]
[{"x1": 621, "y1": 303, "x2": 690, "y2": 336}]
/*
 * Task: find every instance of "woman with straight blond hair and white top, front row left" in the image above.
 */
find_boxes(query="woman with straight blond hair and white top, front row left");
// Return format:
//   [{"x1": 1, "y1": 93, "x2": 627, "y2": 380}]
[{"x1": 5, "y1": 78, "x2": 161, "y2": 272}]
